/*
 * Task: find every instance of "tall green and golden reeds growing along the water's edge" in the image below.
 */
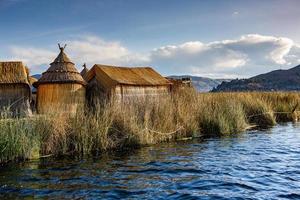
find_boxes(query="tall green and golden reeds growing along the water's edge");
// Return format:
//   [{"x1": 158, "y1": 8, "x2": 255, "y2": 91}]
[{"x1": 0, "y1": 90, "x2": 300, "y2": 163}]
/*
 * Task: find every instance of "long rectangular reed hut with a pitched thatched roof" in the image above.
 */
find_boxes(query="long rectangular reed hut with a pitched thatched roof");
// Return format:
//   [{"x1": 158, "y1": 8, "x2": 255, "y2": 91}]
[{"x1": 85, "y1": 64, "x2": 171, "y2": 101}]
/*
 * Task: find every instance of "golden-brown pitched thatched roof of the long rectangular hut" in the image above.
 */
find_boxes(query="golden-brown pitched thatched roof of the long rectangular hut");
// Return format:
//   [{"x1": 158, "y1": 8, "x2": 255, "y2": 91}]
[{"x1": 86, "y1": 64, "x2": 172, "y2": 86}]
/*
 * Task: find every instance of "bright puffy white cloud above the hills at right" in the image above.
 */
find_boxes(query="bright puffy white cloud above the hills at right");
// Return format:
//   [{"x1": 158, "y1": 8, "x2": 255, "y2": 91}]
[{"x1": 151, "y1": 34, "x2": 300, "y2": 77}]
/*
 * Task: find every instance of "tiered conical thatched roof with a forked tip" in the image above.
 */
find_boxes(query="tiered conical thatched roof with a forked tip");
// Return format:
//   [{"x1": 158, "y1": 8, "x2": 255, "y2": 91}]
[{"x1": 34, "y1": 45, "x2": 86, "y2": 87}]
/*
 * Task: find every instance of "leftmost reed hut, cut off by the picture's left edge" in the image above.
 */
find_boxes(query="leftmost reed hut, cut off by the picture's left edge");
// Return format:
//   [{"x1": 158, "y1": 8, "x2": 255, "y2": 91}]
[{"x1": 0, "y1": 61, "x2": 31, "y2": 115}]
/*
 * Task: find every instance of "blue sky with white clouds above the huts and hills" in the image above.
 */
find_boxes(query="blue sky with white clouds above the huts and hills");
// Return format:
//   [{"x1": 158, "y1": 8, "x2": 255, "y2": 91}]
[{"x1": 0, "y1": 0, "x2": 300, "y2": 78}]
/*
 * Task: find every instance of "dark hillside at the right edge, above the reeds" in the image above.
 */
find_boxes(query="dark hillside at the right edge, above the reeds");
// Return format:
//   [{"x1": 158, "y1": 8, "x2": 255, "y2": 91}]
[{"x1": 213, "y1": 65, "x2": 300, "y2": 92}]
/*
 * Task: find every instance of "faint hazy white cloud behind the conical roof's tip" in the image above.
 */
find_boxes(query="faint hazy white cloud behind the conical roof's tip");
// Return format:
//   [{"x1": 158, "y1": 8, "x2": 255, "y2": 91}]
[{"x1": 10, "y1": 36, "x2": 148, "y2": 73}]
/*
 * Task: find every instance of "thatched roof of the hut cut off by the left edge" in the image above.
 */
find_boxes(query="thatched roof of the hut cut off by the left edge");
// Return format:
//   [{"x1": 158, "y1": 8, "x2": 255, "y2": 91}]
[{"x1": 0, "y1": 61, "x2": 29, "y2": 85}]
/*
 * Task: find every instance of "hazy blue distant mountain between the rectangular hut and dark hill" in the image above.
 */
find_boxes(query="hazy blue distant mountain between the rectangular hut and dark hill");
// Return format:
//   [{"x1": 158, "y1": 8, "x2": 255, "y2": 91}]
[{"x1": 169, "y1": 75, "x2": 231, "y2": 92}]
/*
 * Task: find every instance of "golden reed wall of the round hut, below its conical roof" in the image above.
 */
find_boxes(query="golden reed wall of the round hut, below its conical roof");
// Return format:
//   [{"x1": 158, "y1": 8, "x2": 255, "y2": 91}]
[{"x1": 37, "y1": 83, "x2": 85, "y2": 114}]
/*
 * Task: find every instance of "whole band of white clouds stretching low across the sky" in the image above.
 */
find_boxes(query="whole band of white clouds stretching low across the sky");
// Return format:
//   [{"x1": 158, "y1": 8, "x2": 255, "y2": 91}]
[{"x1": 10, "y1": 34, "x2": 300, "y2": 78}]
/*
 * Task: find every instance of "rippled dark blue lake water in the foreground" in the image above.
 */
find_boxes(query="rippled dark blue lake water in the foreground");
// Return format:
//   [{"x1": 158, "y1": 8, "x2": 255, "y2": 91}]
[{"x1": 0, "y1": 123, "x2": 300, "y2": 199}]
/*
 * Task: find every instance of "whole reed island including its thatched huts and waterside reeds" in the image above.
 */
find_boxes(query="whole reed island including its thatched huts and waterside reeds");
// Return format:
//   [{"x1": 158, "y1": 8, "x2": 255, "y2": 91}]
[{"x1": 0, "y1": 44, "x2": 300, "y2": 163}]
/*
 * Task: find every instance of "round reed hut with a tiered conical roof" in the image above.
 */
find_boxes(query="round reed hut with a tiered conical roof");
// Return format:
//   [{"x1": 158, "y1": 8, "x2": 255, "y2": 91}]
[{"x1": 34, "y1": 45, "x2": 86, "y2": 114}]
